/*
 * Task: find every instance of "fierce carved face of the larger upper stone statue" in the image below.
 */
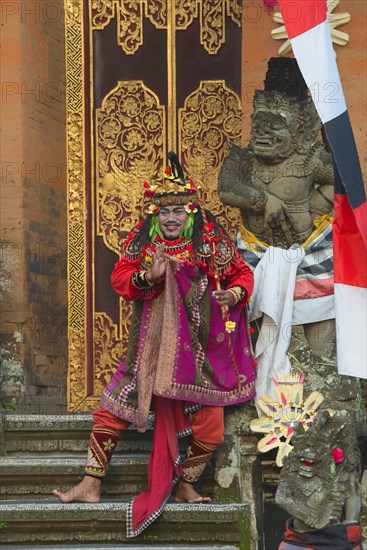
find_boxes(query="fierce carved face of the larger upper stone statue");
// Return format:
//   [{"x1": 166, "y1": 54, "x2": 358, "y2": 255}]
[{"x1": 251, "y1": 111, "x2": 292, "y2": 164}]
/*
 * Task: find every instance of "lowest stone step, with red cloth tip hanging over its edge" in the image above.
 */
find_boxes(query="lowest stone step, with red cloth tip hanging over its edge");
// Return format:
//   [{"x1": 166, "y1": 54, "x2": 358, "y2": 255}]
[{"x1": 0, "y1": 502, "x2": 251, "y2": 550}]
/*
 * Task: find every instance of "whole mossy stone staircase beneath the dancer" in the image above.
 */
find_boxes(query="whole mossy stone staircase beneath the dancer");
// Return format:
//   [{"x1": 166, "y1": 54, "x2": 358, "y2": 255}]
[{"x1": 0, "y1": 414, "x2": 253, "y2": 550}]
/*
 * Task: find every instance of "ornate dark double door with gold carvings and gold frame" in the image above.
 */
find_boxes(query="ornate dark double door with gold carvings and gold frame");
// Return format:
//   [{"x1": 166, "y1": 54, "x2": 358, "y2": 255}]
[{"x1": 65, "y1": 0, "x2": 242, "y2": 412}]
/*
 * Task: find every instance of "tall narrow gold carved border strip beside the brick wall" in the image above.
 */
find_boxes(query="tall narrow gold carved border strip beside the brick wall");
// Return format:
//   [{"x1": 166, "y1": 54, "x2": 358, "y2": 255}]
[{"x1": 65, "y1": 0, "x2": 87, "y2": 412}]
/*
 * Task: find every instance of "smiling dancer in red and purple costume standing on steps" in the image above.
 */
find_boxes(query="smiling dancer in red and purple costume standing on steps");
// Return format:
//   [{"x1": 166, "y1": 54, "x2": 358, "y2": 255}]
[{"x1": 54, "y1": 153, "x2": 255, "y2": 537}]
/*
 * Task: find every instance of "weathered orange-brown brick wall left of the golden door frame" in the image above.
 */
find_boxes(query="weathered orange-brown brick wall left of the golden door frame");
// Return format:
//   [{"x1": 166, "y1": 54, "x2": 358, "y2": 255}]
[{"x1": 0, "y1": 0, "x2": 67, "y2": 413}]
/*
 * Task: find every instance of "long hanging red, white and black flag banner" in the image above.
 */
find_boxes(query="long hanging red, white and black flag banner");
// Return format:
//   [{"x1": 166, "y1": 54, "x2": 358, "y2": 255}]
[{"x1": 278, "y1": 0, "x2": 367, "y2": 378}]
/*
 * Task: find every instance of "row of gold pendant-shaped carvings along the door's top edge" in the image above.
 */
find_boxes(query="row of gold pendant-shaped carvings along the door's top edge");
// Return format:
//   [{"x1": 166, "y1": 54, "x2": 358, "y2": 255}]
[{"x1": 90, "y1": 0, "x2": 242, "y2": 55}]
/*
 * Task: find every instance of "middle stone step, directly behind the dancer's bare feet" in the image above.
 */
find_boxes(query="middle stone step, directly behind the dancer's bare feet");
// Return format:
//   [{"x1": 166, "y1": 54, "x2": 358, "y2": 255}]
[{"x1": 0, "y1": 454, "x2": 213, "y2": 501}]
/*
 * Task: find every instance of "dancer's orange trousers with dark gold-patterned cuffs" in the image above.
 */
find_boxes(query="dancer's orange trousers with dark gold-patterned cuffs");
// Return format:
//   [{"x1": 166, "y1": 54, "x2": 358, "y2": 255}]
[{"x1": 85, "y1": 406, "x2": 224, "y2": 483}]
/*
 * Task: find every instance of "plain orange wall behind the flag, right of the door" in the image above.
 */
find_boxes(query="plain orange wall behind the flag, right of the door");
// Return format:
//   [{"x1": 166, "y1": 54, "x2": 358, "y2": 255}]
[{"x1": 242, "y1": 0, "x2": 367, "y2": 182}]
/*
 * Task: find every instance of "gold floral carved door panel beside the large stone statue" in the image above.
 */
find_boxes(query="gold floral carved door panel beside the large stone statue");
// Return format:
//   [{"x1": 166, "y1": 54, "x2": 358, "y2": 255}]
[{"x1": 179, "y1": 80, "x2": 241, "y2": 237}]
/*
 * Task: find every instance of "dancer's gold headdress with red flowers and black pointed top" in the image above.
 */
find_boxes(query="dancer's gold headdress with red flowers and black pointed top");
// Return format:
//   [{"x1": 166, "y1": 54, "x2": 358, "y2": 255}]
[{"x1": 144, "y1": 151, "x2": 196, "y2": 214}]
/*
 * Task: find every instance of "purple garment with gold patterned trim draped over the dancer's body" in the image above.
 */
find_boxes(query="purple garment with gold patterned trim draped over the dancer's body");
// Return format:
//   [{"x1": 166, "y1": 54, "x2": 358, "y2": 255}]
[{"x1": 101, "y1": 260, "x2": 255, "y2": 431}]
